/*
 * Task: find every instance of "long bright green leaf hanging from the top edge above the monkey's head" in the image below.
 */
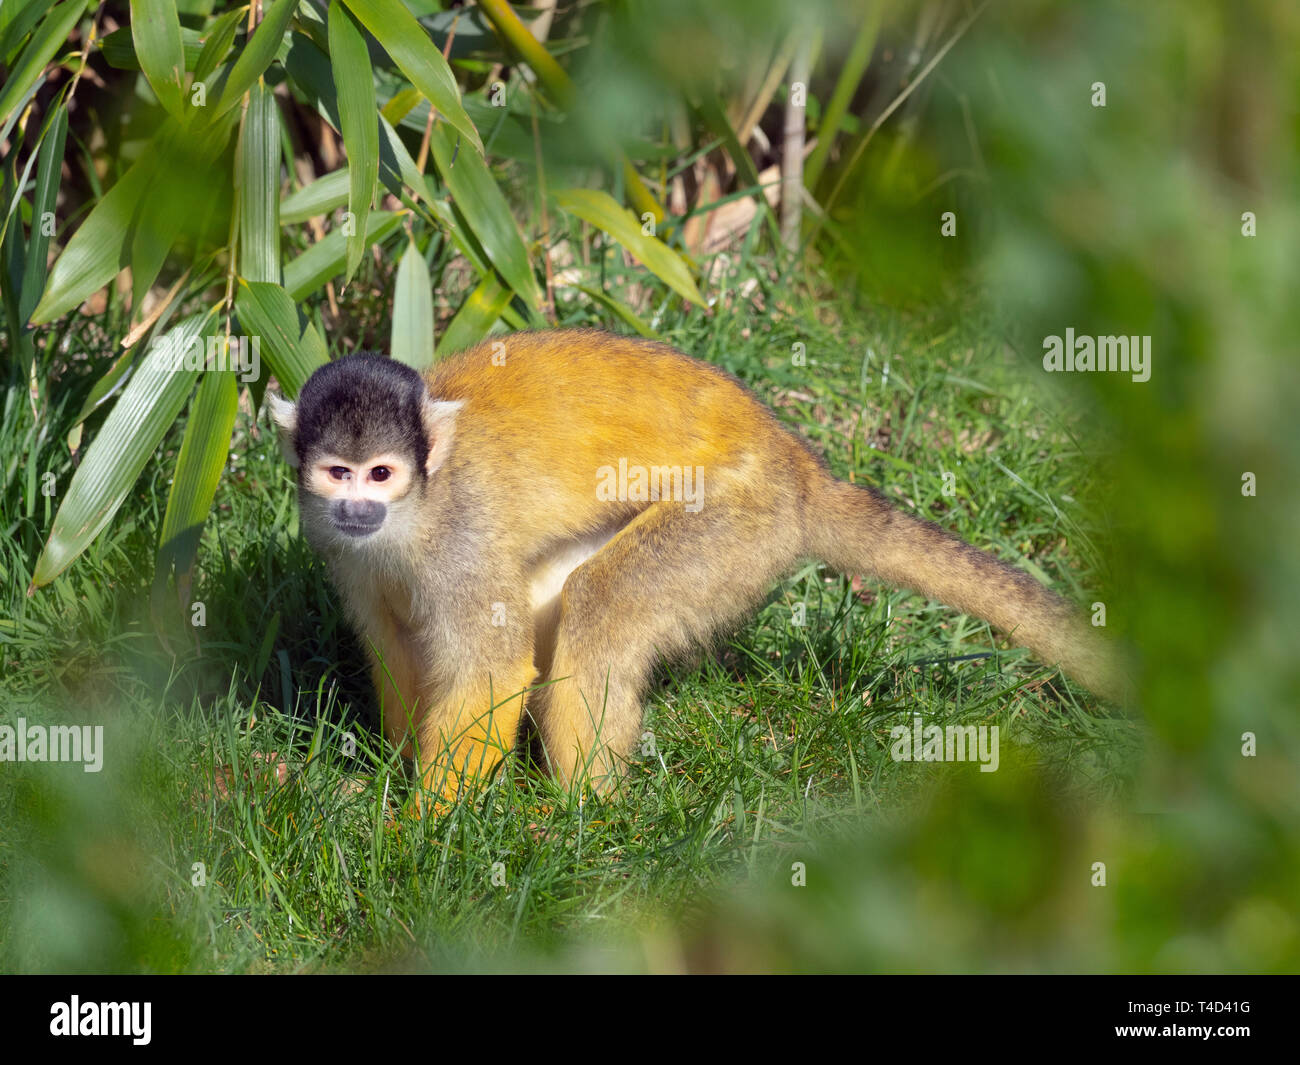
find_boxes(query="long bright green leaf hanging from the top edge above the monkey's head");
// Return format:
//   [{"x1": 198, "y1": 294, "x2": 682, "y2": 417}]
[{"x1": 329, "y1": 0, "x2": 380, "y2": 286}]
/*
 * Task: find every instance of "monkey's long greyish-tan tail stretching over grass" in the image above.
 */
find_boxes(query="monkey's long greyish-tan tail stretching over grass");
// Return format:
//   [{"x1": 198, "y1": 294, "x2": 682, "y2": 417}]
[{"x1": 805, "y1": 477, "x2": 1131, "y2": 702}]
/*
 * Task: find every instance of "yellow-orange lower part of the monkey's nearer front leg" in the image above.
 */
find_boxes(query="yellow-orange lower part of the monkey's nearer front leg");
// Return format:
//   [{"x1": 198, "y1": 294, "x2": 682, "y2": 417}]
[{"x1": 416, "y1": 598, "x2": 536, "y2": 801}]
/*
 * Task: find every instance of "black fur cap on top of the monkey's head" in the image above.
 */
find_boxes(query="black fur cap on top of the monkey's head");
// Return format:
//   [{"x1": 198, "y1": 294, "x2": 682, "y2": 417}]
[{"x1": 294, "y1": 352, "x2": 429, "y2": 472}]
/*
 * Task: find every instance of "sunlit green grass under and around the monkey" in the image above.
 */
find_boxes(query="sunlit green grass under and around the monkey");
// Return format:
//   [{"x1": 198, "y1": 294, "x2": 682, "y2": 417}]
[{"x1": 0, "y1": 264, "x2": 1141, "y2": 971}]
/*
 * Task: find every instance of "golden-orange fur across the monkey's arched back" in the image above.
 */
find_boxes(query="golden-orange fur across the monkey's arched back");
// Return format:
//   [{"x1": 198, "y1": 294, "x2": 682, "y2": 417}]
[{"x1": 426, "y1": 329, "x2": 816, "y2": 540}]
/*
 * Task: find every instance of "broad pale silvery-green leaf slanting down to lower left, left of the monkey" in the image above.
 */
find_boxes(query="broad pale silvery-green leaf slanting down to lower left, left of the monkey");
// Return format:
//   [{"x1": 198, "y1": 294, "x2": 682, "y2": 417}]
[{"x1": 31, "y1": 313, "x2": 213, "y2": 588}]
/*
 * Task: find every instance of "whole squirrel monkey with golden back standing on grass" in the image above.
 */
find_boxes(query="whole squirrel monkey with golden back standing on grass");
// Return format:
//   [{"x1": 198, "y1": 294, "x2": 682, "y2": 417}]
[{"x1": 270, "y1": 330, "x2": 1121, "y2": 798}]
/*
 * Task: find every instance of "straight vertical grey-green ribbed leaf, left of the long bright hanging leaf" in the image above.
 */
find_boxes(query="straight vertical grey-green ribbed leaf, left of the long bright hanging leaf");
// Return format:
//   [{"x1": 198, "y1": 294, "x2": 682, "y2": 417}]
[{"x1": 235, "y1": 81, "x2": 280, "y2": 283}]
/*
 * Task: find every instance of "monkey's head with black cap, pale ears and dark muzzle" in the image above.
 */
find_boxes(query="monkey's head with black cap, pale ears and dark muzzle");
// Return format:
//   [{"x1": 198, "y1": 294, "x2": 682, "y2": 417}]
[{"x1": 268, "y1": 355, "x2": 462, "y2": 550}]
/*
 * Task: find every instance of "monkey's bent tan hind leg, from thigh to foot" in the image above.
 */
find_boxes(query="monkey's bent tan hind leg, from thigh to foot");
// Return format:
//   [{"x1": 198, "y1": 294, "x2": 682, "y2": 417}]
[{"x1": 529, "y1": 497, "x2": 798, "y2": 792}]
